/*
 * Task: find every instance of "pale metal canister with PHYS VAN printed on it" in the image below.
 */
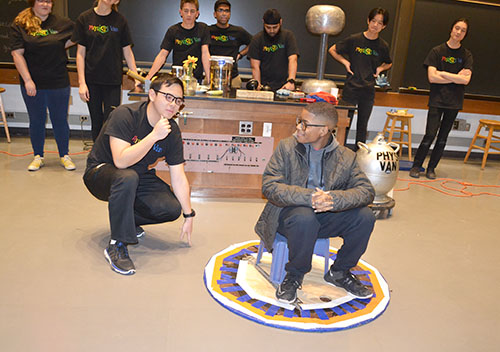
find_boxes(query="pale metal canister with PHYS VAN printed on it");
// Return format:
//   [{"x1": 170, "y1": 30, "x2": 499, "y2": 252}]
[{"x1": 356, "y1": 133, "x2": 399, "y2": 204}]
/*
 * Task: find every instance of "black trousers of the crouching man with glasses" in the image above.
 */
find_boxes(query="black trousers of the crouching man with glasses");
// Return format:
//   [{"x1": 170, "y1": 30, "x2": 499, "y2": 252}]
[{"x1": 83, "y1": 164, "x2": 182, "y2": 244}]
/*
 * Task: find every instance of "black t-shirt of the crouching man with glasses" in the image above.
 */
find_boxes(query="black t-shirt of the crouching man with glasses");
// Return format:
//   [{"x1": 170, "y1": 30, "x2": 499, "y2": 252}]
[{"x1": 87, "y1": 102, "x2": 185, "y2": 174}]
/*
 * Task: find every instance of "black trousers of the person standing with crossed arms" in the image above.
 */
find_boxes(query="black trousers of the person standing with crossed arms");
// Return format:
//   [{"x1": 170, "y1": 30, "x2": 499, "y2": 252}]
[{"x1": 413, "y1": 107, "x2": 458, "y2": 169}]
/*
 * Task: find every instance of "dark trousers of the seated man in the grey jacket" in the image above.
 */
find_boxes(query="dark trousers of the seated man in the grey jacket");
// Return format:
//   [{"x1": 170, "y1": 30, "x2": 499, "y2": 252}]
[{"x1": 278, "y1": 207, "x2": 375, "y2": 277}]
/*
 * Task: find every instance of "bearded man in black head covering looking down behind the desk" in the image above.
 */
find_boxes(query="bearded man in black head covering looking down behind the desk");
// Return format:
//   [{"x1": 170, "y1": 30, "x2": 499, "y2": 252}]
[{"x1": 248, "y1": 9, "x2": 299, "y2": 90}]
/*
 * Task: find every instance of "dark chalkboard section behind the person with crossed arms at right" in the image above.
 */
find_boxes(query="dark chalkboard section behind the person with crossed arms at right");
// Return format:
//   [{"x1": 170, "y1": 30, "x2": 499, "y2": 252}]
[{"x1": 403, "y1": 0, "x2": 500, "y2": 96}]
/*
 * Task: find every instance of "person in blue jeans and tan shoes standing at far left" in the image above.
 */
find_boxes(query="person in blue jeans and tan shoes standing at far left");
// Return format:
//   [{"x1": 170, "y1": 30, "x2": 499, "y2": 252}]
[{"x1": 9, "y1": 0, "x2": 75, "y2": 171}]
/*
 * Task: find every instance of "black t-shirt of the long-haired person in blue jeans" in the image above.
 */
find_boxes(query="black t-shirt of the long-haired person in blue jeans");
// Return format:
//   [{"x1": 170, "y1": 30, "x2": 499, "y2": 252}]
[{"x1": 9, "y1": 14, "x2": 74, "y2": 89}]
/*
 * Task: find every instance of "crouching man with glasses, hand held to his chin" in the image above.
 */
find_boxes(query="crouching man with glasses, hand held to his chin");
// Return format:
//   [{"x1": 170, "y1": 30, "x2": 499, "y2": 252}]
[{"x1": 83, "y1": 74, "x2": 195, "y2": 275}]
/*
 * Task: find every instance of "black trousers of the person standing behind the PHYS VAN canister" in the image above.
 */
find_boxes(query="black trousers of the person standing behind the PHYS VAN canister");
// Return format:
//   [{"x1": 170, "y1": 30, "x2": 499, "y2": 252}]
[{"x1": 340, "y1": 89, "x2": 375, "y2": 151}]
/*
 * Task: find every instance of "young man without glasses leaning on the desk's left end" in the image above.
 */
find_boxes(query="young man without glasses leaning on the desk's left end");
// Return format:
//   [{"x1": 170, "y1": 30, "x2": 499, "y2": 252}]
[{"x1": 146, "y1": 0, "x2": 210, "y2": 83}]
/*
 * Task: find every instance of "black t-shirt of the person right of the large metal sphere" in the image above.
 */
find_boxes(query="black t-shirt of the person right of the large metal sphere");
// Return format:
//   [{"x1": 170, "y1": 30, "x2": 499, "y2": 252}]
[{"x1": 336, "y1": 33, "x2": 392, "y2": 94}]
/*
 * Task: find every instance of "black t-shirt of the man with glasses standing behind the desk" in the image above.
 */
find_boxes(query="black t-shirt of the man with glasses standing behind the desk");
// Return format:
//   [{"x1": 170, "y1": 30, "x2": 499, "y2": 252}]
[{"x1": 208, "y1": 24, "x2": 252, "y2": 78}]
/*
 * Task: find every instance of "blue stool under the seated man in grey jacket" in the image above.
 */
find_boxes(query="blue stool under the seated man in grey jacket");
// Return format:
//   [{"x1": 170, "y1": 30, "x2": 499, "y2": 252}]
[{"x1": 255, "y1": 233, "x2": 330, "y2": 285}]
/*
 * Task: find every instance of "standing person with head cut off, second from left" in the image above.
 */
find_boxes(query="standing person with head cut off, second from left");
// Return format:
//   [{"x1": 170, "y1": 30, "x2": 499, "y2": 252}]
[{"x1": 71, "y1": 0, "x2": 138, "y2": 141}]
